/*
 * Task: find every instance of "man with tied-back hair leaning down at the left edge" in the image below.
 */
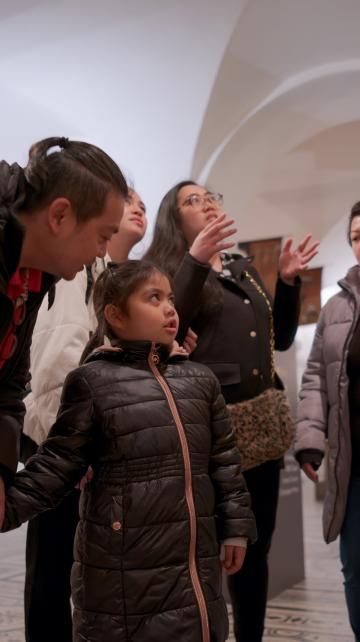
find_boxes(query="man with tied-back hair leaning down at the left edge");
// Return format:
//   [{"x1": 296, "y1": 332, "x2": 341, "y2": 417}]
[{"x1": 0, "y1": 138, "x2": 128, "y2": 525}]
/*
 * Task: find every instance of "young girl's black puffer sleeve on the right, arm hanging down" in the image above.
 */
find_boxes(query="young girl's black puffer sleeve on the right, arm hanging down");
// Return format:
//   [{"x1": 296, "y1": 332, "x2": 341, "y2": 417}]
[{"x1": 210, "y1": 378, "x2": 256, "y2": 542}]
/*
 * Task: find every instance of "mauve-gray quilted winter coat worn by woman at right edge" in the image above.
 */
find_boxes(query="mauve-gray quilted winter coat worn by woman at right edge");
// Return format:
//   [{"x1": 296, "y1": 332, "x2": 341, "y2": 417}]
[{"x1": 295, "y1": 265, "x2": 360, "y2": 542}]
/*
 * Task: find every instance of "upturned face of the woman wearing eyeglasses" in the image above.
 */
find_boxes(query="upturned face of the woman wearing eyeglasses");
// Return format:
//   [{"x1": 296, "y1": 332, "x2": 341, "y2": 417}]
[{"x1": 178, "y1": 185, "x2": 222, "y2": 247}]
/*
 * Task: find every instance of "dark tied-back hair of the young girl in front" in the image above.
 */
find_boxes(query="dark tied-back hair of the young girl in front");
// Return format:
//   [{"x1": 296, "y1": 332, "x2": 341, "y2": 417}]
[{"x1": 80, "y1": 259, "x2": 170, "y2": 363}]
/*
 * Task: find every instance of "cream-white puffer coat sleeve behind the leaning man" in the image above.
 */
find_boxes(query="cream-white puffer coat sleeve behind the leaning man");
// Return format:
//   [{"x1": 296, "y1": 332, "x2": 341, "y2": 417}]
[{"x1": 24, "y1": 271, "x2": 90, "y2": 445}]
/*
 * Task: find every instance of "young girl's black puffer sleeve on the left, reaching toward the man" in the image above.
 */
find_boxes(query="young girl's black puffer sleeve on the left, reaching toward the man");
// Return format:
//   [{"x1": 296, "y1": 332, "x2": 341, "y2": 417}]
[{"x1": 3, "y1": 369, "x2": 94, "y2": 531}]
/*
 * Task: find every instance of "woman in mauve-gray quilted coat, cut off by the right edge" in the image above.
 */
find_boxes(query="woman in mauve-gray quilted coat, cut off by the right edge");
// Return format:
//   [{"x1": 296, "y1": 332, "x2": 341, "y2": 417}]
[{"x1": 295, "y1": 202, "x2": 360, "y2": 642}]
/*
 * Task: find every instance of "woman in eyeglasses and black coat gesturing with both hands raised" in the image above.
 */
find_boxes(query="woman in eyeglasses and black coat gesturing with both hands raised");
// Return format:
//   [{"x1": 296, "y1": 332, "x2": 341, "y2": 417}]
[{"x1": 146, "y1": 181, "x2": 318, "y2": 642}]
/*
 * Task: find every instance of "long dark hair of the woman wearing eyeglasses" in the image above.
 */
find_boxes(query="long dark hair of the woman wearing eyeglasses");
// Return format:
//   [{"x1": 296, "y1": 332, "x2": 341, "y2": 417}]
[{"x1": 144, "y1": 180, "x2": 223, "y2": 317}]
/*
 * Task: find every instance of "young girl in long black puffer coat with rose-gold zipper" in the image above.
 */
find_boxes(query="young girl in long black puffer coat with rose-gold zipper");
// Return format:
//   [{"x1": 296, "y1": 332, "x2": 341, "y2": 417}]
[{"x1": 5, "y1": 261, "x2": 255, "y2": 642}]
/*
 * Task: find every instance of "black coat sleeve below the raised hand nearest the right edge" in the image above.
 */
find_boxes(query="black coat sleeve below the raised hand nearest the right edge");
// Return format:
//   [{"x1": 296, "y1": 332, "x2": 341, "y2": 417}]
[{"x1": 273, "y1": 277, "x2": 301, "y2": 350}]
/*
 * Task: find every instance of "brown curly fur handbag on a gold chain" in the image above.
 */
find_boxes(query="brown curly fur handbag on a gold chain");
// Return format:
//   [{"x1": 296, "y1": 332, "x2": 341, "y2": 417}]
[{"x1": 227, "y1": 388, "x2": 294, "y2": 470}]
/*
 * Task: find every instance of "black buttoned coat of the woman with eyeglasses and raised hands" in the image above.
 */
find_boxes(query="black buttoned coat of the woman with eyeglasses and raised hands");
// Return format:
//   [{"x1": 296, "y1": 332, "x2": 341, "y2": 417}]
[{"x1": 174, "y1": 253, "x2": 301, "y2": 403}]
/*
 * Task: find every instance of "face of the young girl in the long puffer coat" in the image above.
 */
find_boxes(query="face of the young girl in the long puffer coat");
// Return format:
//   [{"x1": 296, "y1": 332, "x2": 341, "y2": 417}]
[{"x1": 105, "y1": 270, "x2": 179, "y2": 346}]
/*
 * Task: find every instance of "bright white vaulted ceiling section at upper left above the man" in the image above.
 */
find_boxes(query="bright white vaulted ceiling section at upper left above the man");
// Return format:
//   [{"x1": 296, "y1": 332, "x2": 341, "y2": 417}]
[{"x1": 0, "y1": 0, "x2": 245, "y2": 240}]
